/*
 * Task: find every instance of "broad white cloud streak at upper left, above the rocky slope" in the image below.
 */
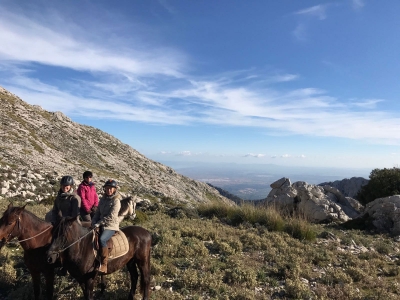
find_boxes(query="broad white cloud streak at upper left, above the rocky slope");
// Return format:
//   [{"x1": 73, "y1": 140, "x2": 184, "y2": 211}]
[{"x1": 0, "y1": 8, "x2": 185, "y2": 77}]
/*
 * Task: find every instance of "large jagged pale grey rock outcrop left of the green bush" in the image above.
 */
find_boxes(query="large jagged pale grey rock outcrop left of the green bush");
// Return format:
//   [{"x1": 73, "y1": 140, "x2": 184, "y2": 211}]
[{"x1": 264, "y1": 177, "x2": 363, "y2": 223}]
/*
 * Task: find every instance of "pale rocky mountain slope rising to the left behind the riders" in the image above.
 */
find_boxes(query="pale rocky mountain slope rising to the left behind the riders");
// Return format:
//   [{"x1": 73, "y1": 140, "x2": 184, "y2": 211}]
[{"x1": 0, "y1": 87, "x2": 233, "y2": 204}]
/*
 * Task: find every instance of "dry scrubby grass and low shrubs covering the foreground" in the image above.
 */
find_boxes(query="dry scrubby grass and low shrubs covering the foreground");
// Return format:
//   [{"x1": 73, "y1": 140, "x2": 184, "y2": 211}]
[{"x1": 0, "y1": 203, "x2": 400, "y2": 300}]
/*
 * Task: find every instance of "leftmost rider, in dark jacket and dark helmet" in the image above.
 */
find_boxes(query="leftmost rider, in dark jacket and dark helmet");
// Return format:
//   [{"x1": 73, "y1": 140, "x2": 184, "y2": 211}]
[{"x1": 51, "y1": 175, "x2": 81, "y2": 224}]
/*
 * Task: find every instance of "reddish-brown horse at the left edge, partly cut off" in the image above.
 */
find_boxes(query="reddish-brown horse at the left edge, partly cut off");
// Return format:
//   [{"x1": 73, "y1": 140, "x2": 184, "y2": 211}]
[{"x1": 0, "y1": 203, "x2": 59, "y2": 299}]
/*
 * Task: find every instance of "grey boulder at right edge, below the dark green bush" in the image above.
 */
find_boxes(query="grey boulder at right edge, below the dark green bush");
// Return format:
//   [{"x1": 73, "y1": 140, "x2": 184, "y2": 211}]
[{"x1": 360, "y1": 195, "x2": 400, "y2": 235}]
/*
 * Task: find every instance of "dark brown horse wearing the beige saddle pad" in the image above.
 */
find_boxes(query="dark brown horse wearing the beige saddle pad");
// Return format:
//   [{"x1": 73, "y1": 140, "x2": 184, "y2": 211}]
[{"x1": 48, "y1": 217, "x2": 151, "y2": 300}]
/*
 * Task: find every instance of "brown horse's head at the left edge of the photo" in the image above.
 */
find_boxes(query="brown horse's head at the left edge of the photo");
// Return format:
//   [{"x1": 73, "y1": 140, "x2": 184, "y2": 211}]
[{"x1": 0, "y1": 203, "x2": 26, "y2": 249}]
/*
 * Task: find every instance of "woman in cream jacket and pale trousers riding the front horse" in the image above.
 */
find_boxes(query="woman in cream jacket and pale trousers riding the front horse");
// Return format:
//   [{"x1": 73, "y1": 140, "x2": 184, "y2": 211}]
[{"x1": 92, "y1": 179, "x2": 122, "y2": 274}]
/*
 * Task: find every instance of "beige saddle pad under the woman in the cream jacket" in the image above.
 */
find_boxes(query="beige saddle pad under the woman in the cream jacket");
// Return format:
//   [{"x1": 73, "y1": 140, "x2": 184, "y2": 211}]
[{"x1": 93, "y1": 228, "x2": 129, "y2": 260}]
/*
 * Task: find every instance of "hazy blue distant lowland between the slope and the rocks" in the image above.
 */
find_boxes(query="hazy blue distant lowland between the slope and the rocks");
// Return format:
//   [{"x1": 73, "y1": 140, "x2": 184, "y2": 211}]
[{"x1": 161, "y1": 161, "x2": 372, "y2": 200}]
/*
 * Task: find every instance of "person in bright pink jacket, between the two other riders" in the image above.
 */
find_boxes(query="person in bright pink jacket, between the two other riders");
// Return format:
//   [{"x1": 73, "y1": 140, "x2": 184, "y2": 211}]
[{"x1": 77, "y1": 171, "x2": 99, "y2": 221}]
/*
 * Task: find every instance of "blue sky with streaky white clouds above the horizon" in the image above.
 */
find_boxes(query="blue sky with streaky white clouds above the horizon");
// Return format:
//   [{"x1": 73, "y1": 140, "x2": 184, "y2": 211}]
[{"x1": 0, "y1": 0, "x2": 400, "y2": 169}]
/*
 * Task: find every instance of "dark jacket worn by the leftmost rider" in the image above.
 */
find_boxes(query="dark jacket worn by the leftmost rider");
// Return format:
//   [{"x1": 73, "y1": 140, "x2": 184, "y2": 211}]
[{"x1": 51, "y1": 188, "x2": 81, "y2": 223}]
